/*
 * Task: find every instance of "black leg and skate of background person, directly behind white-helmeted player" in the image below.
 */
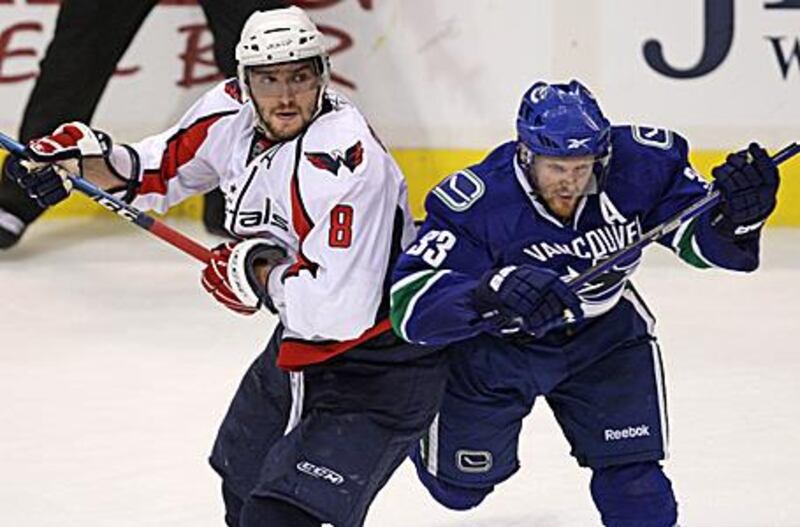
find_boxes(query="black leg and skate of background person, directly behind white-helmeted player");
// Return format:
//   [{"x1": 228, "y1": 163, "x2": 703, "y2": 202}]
[{"x1": 200, "y1": 0, "x2": 287, "y2": 236}]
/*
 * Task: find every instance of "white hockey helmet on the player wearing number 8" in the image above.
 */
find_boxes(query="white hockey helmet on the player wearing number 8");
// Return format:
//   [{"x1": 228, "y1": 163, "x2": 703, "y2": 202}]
[{"x1": 236, "y1": 6, "x2": 330, "y2": 99}]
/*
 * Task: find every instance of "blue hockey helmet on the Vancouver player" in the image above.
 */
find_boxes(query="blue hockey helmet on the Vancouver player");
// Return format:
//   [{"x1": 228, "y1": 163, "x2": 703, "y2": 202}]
[{"x1": 517, "y1": 80, "x2": 611, "y2": 190}]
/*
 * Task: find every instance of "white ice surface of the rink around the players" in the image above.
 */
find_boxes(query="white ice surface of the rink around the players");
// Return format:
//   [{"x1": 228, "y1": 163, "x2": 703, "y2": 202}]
[{"x1": 0, "y1": 219, "x2": 800, "y2": 527}]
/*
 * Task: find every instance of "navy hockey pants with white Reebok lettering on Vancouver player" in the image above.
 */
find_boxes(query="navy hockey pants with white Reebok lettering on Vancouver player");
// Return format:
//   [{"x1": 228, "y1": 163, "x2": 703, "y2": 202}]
[{"x1": 412, "y1": 291, "x2": 667, "y2": 490}]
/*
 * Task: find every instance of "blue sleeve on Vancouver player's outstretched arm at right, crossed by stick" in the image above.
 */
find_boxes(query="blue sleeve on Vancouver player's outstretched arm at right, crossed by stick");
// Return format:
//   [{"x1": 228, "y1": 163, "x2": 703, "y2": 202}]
[{"x1": 642, "y1": 134, "x2": 759, "y2": 271}]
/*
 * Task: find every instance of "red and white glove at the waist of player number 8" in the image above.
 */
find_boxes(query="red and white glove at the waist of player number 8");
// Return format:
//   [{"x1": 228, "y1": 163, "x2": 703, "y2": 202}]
[{"x1": 201, "y1": 239, "x2": 286, "y2": 315}]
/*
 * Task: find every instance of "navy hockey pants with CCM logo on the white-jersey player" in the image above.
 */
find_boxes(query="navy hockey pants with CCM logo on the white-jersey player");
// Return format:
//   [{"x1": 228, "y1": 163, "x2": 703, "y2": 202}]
[{"x1": 210, "y1": 330, "x2": 446, "y2": 527}]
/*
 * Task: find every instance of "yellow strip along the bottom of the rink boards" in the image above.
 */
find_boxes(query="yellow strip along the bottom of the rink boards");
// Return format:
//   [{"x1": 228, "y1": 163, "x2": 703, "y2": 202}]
[{"x1": 0, "y1": 149, "x2": 800, "y2": 226}]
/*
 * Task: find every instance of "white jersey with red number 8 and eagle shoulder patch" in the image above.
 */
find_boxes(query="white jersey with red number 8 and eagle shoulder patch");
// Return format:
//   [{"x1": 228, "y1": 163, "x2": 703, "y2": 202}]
[{"x1": 123, "y1": 80, "x2": 415, "y2": 369}]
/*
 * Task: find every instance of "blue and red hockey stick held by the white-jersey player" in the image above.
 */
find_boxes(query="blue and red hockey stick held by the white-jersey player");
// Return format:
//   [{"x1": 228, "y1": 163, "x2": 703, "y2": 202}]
[{"x1": 0, "y1": 132, "x2": 211, "y2": 263}]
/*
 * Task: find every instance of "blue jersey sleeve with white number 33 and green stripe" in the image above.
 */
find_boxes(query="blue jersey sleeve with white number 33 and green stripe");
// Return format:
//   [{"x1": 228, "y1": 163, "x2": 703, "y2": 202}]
[{"x1": 390, "y1": 186, "x2": 492, "y2": 345}]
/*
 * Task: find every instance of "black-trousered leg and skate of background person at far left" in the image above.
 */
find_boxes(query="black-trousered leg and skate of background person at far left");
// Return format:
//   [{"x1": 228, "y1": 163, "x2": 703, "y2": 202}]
[{"x1": 0, "y1": 0, "x2": 157, "y2": 248}]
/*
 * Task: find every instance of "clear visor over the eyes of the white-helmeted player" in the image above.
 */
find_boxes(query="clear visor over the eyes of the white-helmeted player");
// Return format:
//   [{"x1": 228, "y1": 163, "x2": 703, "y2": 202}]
[{"x1": 250, "y1": 60, "x2": 322, "y2": 97}]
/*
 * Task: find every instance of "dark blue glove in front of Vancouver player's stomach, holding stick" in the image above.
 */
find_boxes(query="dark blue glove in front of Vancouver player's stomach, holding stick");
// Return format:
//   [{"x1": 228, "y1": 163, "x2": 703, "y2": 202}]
[{"x1": 474, "y1": 265, "x2": 583, "y2": 337}]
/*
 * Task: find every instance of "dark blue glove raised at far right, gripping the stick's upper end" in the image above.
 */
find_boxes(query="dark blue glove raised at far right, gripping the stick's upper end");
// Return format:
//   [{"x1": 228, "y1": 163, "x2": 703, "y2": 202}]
[{"x1": 711, "y1": 143, "x2": 780, "y2": 236}]
